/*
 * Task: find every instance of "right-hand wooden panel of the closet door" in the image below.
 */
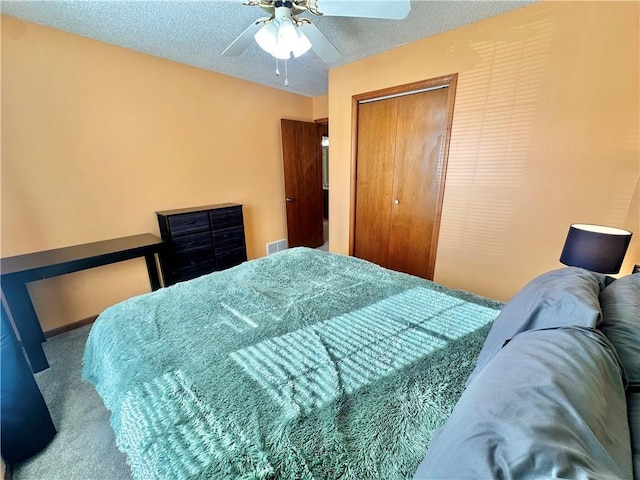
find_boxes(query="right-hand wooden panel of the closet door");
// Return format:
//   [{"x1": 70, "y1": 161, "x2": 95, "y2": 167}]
[{"x1": 388, "y1": 88, "x2": 449, "y2": 278}]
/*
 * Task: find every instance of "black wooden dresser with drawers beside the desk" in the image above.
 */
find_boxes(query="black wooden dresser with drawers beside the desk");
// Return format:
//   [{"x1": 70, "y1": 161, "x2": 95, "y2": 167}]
[{"x1": 156, "y1": 203, "x2": 247, "y2": 286}]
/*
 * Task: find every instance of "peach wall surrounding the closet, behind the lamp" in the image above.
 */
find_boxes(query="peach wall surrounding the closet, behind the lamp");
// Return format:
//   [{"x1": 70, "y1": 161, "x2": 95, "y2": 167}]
[{"x1": 329, "y1": 2, "x2": 640, "y2": 300}]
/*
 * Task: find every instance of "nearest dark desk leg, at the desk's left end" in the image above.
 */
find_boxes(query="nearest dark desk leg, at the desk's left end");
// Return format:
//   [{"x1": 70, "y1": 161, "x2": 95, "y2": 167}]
[{"x1": 2, "y1": 280, "x2": 49, "y2": 373}]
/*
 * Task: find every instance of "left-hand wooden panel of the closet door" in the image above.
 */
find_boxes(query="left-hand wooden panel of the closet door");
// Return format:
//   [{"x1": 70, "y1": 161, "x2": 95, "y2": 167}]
[{"x1": 353, "y1": 99, "x2": 398, "y2": 267}]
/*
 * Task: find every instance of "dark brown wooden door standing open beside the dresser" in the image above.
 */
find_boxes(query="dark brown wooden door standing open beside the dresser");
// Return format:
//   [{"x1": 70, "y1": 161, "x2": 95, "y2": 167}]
[{"x1": 281, "y1": 119, "x2": 324, "y2": 248}]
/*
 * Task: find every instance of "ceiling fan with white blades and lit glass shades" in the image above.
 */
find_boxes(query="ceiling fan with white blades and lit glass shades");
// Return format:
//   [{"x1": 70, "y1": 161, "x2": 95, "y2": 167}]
[{"x1": 222, "y1": 0, "x2": 411, "y2": 63}]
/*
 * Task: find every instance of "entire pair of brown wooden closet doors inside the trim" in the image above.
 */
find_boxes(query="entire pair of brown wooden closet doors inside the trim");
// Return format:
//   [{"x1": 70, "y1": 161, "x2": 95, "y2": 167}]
[{"x1": 354, "y1": 87, "x2": 449, "y2": 278}]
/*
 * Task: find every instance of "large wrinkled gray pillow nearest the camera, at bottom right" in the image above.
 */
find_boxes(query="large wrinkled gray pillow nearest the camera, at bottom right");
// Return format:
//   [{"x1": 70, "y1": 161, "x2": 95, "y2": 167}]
[{"x1": 414, "y1": 327, "x2": 632, "y2": 480}]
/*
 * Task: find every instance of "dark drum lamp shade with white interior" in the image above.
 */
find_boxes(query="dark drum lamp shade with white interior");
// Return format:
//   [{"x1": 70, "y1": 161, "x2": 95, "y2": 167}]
[{"x1": 560, "y1": 223, "x2": 632, "y2": 273}]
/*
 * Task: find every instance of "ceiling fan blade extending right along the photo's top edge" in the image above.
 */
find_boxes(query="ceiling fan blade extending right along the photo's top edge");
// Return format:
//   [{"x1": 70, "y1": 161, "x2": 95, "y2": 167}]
[{"x1": 317, "y1": 0, "x2": 411, "y2": 20}]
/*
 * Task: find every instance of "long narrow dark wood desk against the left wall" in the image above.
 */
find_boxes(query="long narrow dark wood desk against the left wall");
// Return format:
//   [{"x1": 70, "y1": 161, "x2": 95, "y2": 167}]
[{"x1": 0, "y1": 233, "x2": 165, "y2": 373}]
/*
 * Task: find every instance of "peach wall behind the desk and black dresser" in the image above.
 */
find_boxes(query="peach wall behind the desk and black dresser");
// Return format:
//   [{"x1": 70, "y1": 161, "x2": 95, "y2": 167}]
[{"x1": 1, "y1": 16, "x2": 313, "y2": 330}]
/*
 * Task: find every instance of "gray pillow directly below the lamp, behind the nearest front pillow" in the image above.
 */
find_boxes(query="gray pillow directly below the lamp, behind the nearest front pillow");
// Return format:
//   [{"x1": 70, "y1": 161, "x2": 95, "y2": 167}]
[{"x1": 467, "y1": 267, "x2": 607, "y2": 385}]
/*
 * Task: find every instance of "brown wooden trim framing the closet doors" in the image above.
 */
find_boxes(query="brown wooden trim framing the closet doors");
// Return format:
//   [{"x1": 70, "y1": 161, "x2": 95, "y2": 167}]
[{"x1": 349, "y1": 73, "x2": 458, "y2": 278}]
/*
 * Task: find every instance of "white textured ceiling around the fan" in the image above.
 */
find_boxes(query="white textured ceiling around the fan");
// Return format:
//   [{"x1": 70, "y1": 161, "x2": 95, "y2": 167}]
[{"x1": 0, "y1": 0, "x2": 534, "y2": 96}]
